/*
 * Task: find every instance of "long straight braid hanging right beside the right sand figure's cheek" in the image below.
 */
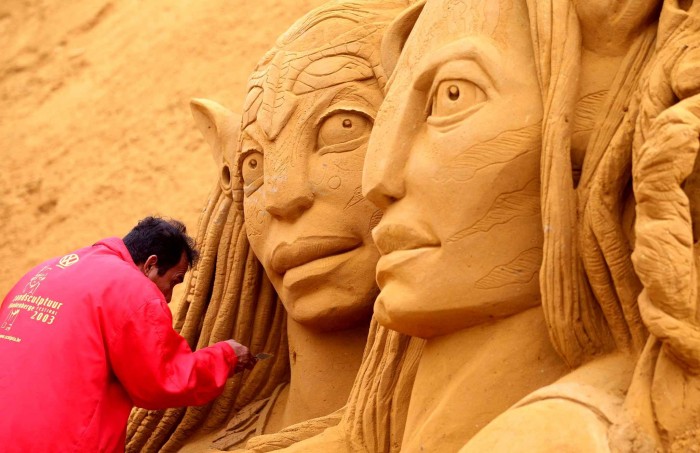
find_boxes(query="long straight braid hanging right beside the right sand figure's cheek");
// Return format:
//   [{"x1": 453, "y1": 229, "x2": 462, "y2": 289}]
[{"x1": 527, "y1": 0, "x2": 611, "y2": 367}]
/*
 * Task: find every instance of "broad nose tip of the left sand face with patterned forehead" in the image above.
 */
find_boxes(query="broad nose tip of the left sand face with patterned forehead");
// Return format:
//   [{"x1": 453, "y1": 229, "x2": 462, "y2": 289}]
[{"x1": 265, "y1": 168, "x2": 314, "y2": 220}]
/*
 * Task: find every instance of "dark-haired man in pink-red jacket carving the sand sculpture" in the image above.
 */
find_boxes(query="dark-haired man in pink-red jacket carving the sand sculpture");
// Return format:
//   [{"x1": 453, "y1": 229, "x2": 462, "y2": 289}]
[{"x1": 0, "y1": 217, "x2": 255, "y2": 452}]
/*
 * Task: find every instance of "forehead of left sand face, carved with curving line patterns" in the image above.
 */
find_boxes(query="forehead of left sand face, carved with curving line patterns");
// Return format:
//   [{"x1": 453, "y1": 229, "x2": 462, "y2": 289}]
[{"x1": 242, "y1": 11, "x2": 384, "y2": 140}]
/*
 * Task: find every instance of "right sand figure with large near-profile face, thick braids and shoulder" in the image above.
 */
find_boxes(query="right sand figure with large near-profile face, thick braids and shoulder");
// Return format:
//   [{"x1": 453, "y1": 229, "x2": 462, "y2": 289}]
[{"x1": 231, "y1": 0, "x2": 700, "y2": 452}]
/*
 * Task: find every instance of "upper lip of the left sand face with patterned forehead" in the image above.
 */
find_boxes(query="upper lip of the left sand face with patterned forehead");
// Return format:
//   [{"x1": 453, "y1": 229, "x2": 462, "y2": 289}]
[{"x1": 271, "y1": 236, "x2": 362, "y2": 274}]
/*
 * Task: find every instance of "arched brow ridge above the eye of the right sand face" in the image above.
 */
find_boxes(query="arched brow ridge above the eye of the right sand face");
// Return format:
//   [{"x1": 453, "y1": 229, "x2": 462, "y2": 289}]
[{"x1": 413, "y1": 38, "x2": 501, "y2": 91}]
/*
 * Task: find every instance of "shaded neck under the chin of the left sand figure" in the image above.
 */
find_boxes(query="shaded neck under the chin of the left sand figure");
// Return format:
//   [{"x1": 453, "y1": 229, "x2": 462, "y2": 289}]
[{"x1": 265, "y1": 318, "x2": 369, "y2": 433}]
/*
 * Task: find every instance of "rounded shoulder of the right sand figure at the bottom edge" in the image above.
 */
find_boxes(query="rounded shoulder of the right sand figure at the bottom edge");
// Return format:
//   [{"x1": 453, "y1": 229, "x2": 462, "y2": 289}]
[{"x1": 460, "y1": 354, "x2": 635, "y2": 453}]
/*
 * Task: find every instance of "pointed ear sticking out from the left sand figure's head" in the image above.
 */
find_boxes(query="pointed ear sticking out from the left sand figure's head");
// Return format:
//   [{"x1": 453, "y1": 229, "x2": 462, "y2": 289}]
[{"x1": 190, "y1": 99, "x2": 241, "y2": 167}]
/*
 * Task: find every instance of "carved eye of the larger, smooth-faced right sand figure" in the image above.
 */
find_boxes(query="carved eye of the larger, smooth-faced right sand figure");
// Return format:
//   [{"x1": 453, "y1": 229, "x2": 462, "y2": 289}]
[{"x1": 428, "y1": 80, "x2": 486, "y2": 119}]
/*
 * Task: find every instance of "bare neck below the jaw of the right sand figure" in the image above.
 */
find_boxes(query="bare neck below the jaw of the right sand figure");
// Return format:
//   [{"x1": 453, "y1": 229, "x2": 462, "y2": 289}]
[{"x1": 402, "y1": 306, "x2": 568, "y2": 452}]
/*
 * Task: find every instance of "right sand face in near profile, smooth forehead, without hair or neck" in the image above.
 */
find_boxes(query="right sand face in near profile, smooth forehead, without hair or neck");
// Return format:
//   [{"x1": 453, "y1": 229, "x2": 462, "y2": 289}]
[{"x1": 363, "y1": 0, "x2": 542, "y2": 338}]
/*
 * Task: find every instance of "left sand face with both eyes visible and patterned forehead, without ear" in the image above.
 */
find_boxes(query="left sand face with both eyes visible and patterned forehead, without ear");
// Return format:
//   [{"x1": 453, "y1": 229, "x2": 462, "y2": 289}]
[{"x1": 238, "y1": 31, "x2": 383, "y2": 330}]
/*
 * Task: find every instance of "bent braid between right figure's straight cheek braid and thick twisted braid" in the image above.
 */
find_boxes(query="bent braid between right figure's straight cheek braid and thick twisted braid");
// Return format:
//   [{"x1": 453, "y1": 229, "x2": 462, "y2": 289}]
[{"x1": 577, "y1": 28, "x2": 655, "y2": 353}]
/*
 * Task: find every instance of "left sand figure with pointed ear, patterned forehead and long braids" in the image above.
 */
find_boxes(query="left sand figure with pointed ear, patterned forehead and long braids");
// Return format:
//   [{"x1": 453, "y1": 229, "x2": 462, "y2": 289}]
[{"x1": 127, "y1": 2, "x2": 406, "y2": 451}]
